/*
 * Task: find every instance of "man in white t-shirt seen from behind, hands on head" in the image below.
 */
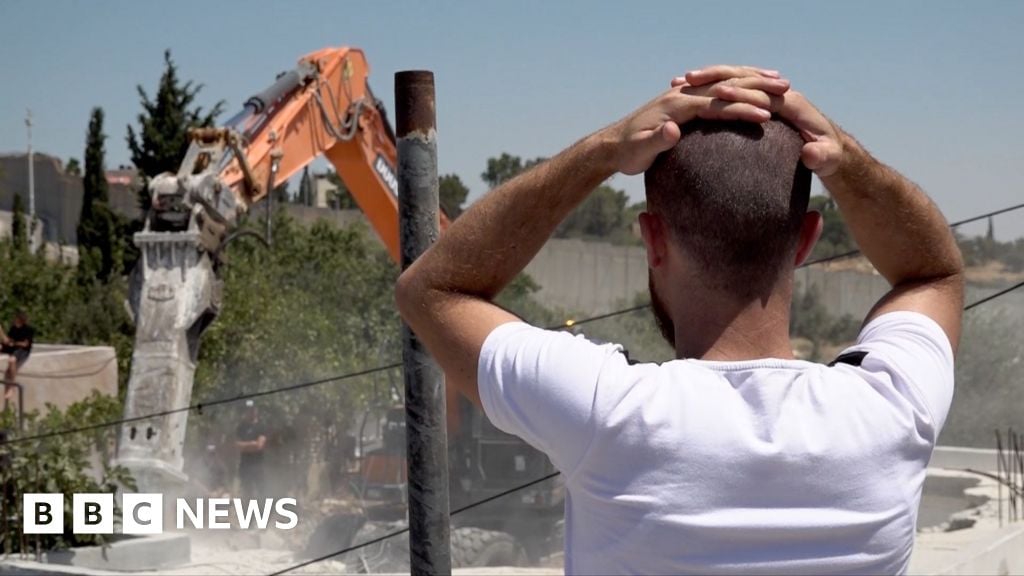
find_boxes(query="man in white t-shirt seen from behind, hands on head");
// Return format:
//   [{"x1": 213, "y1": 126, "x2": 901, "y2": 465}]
[{"x1": 396, "y1": 67, "x2": 964, "y2": 574}]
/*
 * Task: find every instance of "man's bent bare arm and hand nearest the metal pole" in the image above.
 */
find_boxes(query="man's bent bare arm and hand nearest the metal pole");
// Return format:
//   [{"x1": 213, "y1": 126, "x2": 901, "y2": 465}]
[{"x1": 395, "y1": 68, "x2": 788, "y2": 404}]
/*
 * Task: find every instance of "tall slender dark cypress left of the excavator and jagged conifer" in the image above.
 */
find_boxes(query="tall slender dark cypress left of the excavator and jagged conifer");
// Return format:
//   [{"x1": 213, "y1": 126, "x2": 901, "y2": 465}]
[{"x1": 78, "y1": 108, "x2": 124, "y2": 281}]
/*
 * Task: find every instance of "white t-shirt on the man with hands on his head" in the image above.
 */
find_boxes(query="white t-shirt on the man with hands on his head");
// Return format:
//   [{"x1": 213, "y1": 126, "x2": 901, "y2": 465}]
[{"x1": 478, "y1": 312, "x2": 953, "y2": 574}]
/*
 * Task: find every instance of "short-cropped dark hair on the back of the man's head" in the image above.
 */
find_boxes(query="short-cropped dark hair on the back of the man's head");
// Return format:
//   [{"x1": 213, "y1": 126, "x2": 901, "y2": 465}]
[{"x1": 644, "y1": 119, "x2": 811, "y2": 298}]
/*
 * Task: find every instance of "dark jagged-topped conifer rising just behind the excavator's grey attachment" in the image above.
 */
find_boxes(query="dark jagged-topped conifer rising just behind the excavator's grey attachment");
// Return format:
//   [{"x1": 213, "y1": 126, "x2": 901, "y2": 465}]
[{"x1": 127, "y1": 50, "x2": 224, "y2": 211}]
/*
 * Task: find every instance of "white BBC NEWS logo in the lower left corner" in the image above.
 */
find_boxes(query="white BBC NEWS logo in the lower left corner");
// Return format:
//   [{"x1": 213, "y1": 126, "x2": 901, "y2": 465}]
[{"x1": 22, "y1": 494, "x2": 299, "y2": 535}]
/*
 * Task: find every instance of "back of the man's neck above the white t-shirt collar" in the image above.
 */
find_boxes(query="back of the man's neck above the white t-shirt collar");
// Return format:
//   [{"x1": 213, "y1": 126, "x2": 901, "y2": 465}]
[{"x1": 672, "y1": 286, "x2": 794, "y2": 361}]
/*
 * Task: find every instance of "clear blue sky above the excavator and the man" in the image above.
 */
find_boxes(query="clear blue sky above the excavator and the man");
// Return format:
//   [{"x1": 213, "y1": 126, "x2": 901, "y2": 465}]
[{"x1": 0, "y1": 0, "x2": 1024, "y2": 238}]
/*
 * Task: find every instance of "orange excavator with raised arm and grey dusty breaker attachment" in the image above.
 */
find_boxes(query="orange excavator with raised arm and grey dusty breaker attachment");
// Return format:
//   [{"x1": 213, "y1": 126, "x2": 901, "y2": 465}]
[{"x1": 117, "y1": 47, "x2": 561, "y2": 566}]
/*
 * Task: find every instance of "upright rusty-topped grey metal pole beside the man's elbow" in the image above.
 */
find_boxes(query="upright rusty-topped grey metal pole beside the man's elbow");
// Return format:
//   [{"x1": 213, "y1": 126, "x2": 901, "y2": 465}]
[{"x1": 394, "y1": 71, "x2": 452, "y2": 575}]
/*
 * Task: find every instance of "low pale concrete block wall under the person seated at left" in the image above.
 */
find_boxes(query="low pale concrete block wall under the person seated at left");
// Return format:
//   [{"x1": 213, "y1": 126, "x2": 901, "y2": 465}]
[{"x1": 0, "y1": 344, "x2": 118, "y2": 412}]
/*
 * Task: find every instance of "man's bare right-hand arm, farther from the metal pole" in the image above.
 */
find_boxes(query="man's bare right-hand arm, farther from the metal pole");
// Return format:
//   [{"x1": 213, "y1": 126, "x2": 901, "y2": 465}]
[{"x1": 778, "y1": 91, "x2": 964, "y2": 353}]
